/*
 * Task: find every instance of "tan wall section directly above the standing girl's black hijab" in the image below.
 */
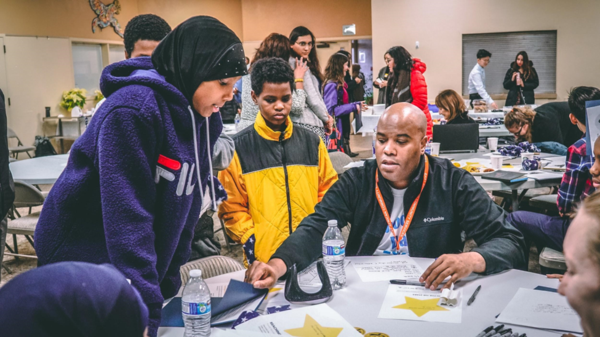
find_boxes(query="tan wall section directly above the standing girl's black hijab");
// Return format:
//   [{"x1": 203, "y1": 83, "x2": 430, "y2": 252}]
[{"x1": 138, "y1": 0, "x2": 243, "y2": 39}]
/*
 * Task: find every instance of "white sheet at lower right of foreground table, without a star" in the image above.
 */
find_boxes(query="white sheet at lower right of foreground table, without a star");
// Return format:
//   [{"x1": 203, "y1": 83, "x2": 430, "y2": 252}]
[{"x1": 496, "y1": 288, "x2": 583, "y2": 333}]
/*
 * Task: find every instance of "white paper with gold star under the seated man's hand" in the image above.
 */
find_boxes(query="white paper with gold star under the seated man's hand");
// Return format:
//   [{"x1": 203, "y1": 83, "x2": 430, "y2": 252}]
[{"x1": 377, "y1": 284, "x2": 463, "y2": 323}]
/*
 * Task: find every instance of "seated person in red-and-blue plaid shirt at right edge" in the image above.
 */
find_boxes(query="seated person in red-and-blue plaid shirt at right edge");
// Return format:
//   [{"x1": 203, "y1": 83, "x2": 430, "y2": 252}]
[{"x1": 508, "y1": 87, "x2": 600, "y2": 252}]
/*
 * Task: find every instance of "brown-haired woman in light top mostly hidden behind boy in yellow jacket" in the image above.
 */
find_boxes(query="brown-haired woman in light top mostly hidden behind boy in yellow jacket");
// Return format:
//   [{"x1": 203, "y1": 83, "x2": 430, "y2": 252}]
[{"x1": 239, "y1": 33, "x2": 308, "y2": 131}]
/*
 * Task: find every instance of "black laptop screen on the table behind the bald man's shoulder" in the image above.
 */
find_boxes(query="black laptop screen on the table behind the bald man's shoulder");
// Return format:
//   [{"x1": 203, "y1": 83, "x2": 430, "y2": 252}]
[{"x1": 433, "y1": 123, "x2": 479, "y2": 153}]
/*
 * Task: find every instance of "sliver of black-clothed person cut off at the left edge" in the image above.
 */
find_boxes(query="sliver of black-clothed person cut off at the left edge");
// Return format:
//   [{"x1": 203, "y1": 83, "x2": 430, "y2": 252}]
[{"x1": 0, "y1": 89, "x2": 15, "y2": 279}]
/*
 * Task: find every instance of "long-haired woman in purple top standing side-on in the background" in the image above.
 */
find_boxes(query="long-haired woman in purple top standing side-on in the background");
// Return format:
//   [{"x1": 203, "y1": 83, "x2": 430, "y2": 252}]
[{"x1": 323, "y1": 53, "x2": 366, "y2": 157}]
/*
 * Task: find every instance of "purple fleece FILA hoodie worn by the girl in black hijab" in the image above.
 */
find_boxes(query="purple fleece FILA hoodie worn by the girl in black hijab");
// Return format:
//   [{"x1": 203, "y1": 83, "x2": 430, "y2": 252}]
[{"x1": 35, "y1": 57, "x2": 225, "y2": 336}]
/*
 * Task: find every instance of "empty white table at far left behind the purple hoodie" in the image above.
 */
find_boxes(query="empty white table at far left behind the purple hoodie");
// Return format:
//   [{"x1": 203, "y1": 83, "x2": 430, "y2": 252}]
[{"x1": 9, "y1": 154, "x2": 69, "y2": 185}]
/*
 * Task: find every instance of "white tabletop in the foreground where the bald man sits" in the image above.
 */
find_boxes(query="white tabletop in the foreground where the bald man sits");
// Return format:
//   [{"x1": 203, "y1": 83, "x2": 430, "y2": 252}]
[{"x1": 158, "y1": 257, "x2": 560, "y2": 337}]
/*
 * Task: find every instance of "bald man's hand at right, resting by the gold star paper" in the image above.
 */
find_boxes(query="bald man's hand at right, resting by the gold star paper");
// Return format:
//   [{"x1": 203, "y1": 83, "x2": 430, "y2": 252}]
[{"x1": 419, "y1": 252, "x2": 485, "y2": 290}]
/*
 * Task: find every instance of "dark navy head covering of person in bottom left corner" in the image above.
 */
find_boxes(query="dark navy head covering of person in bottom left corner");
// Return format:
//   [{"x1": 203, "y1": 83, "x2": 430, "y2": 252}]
[{"x1": 0, "y1": 262, "x2": 148, "y2": 337}]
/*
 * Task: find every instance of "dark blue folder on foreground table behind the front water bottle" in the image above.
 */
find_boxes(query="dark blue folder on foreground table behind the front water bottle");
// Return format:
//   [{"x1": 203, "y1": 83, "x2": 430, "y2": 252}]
[{"x1": 160, "y1": 280, "x2": 268, "y2": 327}]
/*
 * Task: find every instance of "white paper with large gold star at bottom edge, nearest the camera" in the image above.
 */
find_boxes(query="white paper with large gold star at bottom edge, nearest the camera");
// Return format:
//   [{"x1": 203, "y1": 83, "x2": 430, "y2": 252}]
[{"x1": 235, "y1": 304, "x2": 362, "y2": 337}]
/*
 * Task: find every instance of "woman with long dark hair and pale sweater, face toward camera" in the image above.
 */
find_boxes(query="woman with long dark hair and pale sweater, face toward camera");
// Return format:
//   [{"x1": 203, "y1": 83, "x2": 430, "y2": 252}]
[{"x1": 290, "y1": 26, "x2": 333, "y2": 140}]
